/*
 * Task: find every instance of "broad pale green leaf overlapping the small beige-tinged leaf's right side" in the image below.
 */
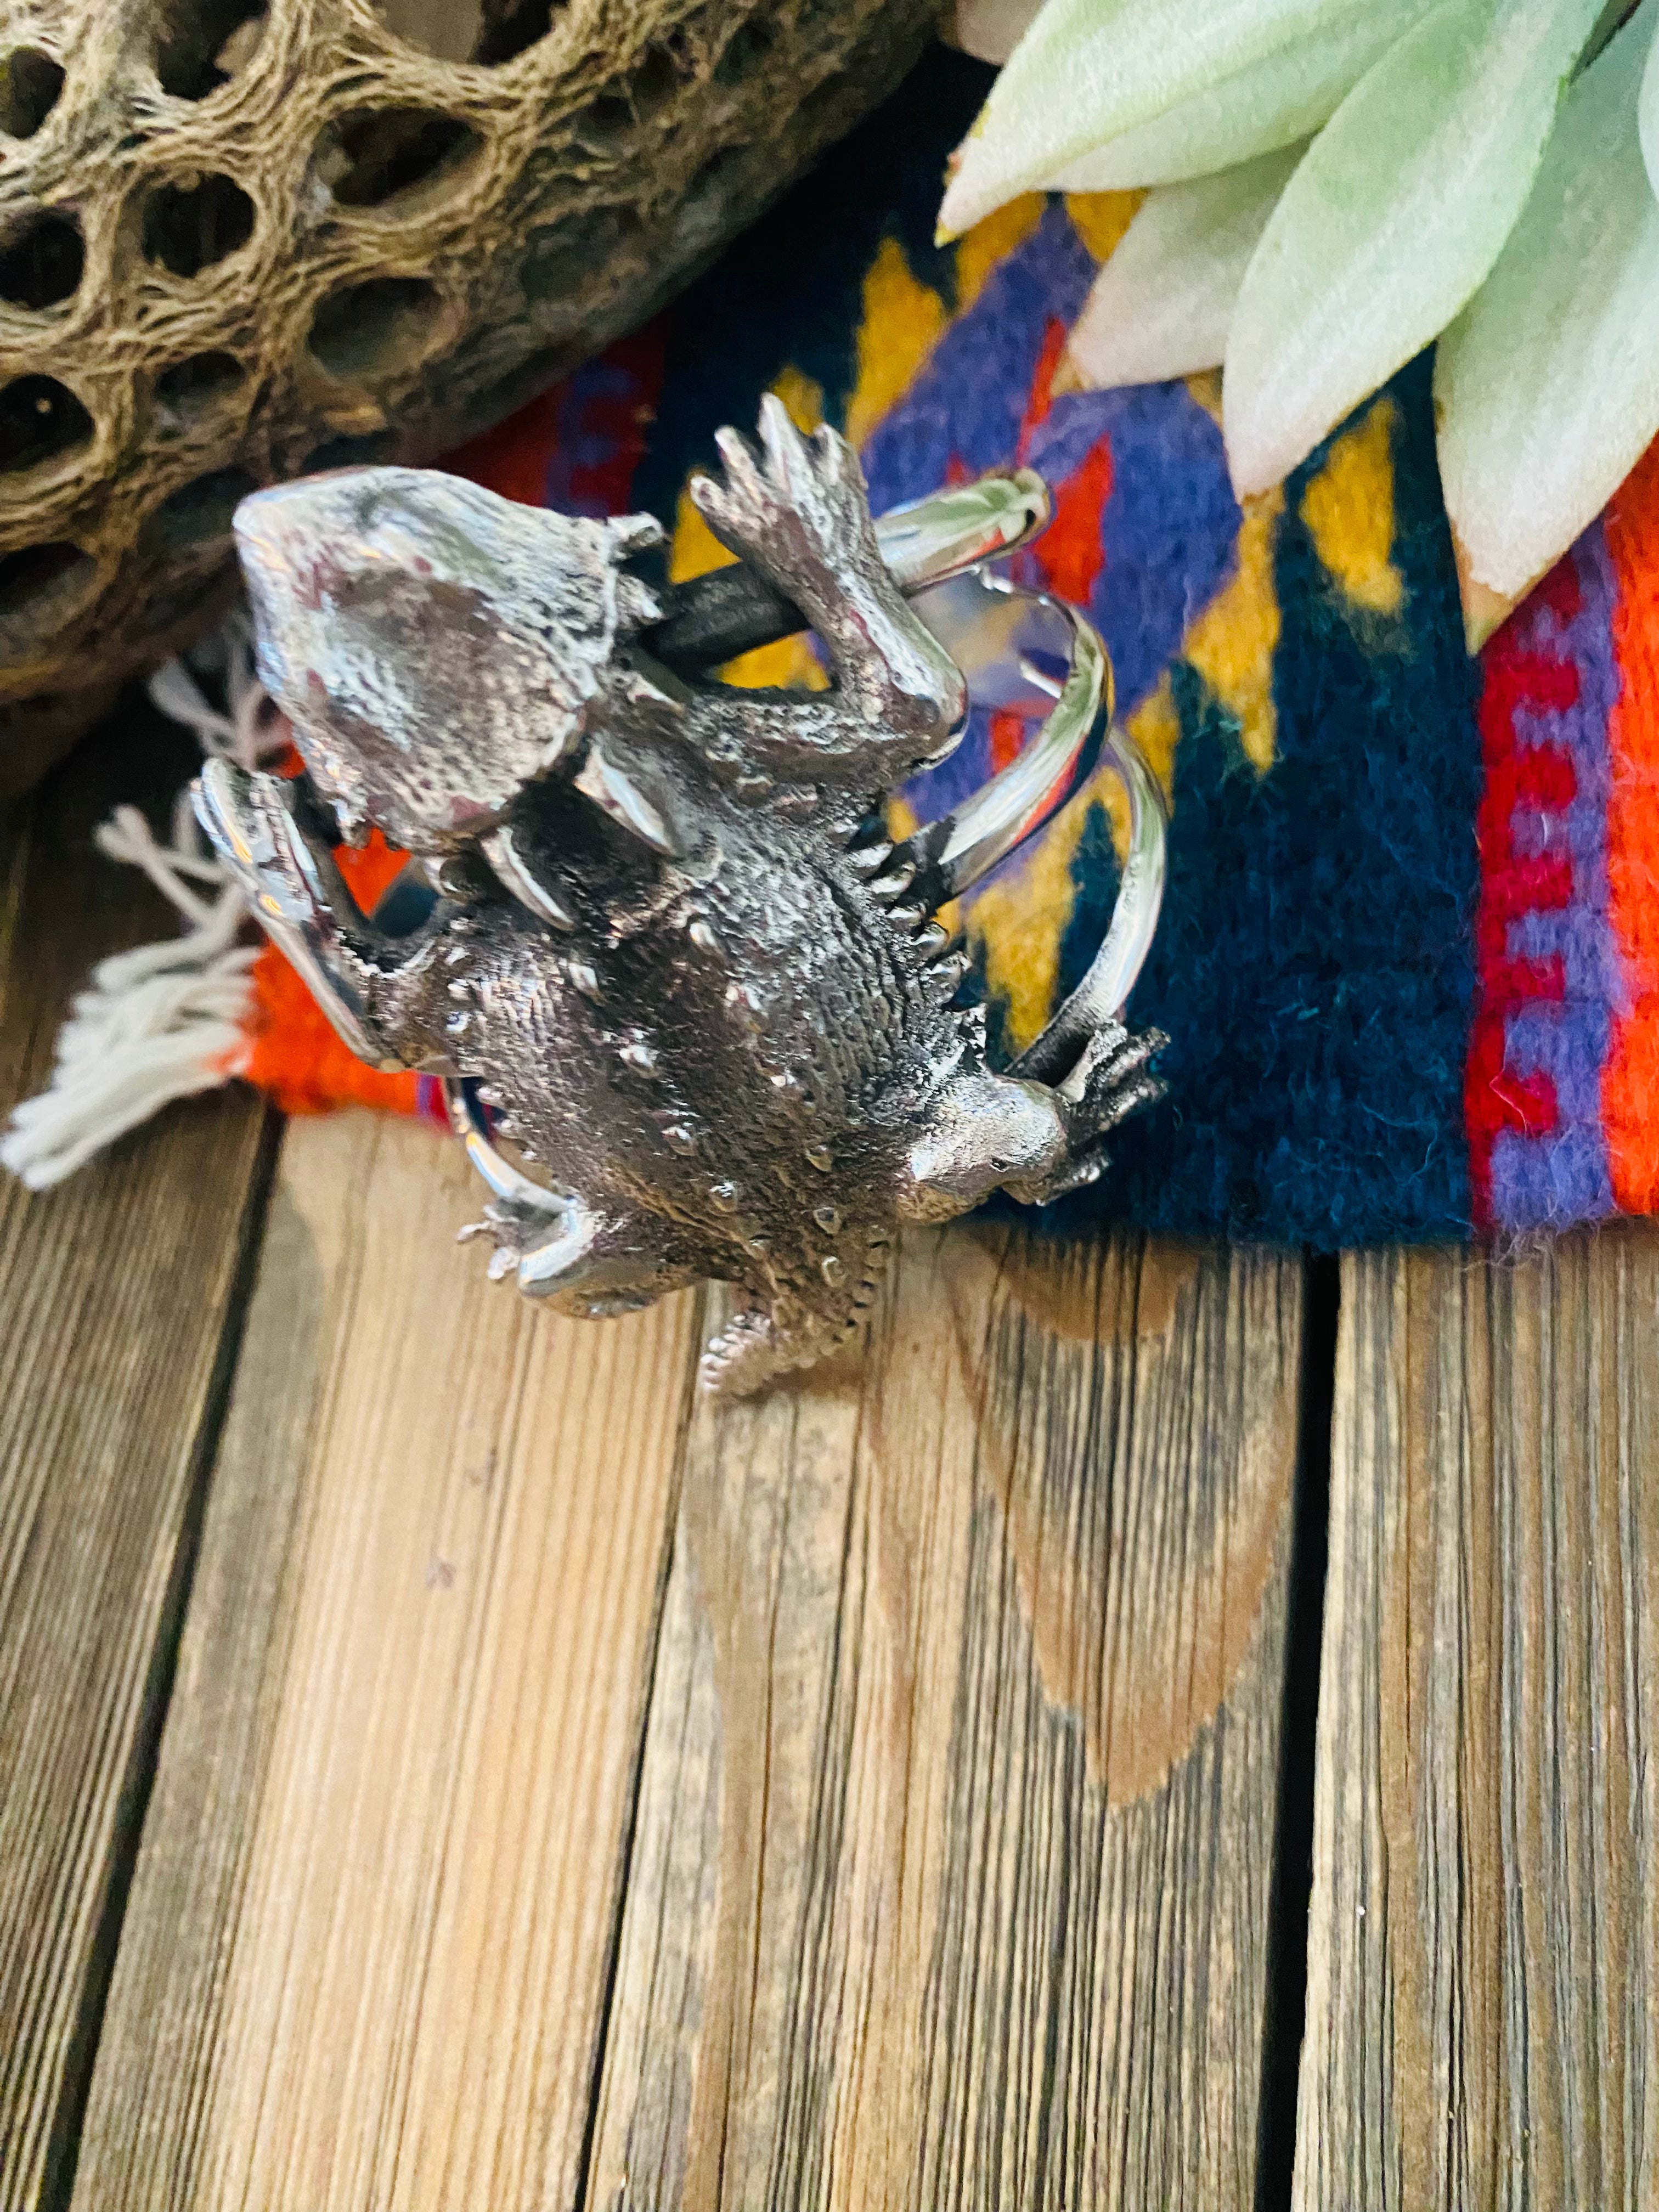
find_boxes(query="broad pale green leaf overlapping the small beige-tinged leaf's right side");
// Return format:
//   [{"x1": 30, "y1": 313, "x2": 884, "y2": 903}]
[{"x1": 1223, "y1": 0, "x2": 1599, "y2": 491}]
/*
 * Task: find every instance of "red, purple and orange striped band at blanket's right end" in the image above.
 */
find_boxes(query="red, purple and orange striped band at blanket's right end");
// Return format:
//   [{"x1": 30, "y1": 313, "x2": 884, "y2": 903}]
[{"x1": 1466, "y1": 449, "x2": 1659, "y2": 1230}]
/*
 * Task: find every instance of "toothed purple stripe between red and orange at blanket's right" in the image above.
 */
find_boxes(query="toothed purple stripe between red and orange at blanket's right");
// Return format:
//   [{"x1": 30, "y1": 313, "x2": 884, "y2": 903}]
[{"x1": 1491, "y1": 522, "x2": 1623, "y2": 1230}]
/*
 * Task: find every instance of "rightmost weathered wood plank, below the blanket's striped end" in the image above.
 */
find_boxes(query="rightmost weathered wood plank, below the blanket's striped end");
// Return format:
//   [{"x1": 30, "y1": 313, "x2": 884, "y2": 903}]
[{"x1": 1294, "y1": 1230, "x2": 1659, "y2": 2212}]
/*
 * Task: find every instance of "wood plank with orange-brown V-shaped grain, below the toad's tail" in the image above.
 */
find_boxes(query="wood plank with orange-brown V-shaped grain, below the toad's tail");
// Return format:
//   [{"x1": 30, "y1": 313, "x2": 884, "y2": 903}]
[{"x1": 586, "y1": 1228, "x2": 1301, "y2": 2212}]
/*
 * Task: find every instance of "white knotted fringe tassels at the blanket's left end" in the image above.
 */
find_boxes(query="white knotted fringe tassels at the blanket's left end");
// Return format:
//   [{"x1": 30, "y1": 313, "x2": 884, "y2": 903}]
[{"x1": 0, "y1": 615, "x2": 287, "y2": 1190}]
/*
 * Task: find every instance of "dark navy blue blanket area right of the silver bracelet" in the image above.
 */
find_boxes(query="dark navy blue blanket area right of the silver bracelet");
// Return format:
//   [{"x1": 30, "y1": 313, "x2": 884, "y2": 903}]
[{"x1": 1106, "y1": 360, "x2": 1480, "y2": 1250}]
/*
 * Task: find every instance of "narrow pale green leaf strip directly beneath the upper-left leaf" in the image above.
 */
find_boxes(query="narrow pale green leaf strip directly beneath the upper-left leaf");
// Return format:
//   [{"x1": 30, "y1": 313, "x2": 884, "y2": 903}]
[{"x1": 1057, "y1": 0, "x2": 1436, "y2": 193}]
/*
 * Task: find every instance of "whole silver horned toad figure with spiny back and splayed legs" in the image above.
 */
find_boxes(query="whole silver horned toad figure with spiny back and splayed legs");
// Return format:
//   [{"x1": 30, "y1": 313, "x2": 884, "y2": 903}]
[{"x1": 197, "y1": 403, "x2": 1164, "y2": 1391}]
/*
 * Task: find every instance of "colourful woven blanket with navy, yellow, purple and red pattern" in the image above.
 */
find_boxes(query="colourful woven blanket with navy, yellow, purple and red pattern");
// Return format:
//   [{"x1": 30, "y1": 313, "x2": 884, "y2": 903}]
[{"x1": 16, "y1": 53, "x2": 1659, "y2": 1248}]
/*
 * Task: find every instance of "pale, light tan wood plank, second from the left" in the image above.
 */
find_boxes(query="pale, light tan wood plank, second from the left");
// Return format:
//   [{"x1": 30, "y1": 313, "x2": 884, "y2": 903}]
[{"x1": 75, "y1": 1117, "x2": 697, "y2": 2212}]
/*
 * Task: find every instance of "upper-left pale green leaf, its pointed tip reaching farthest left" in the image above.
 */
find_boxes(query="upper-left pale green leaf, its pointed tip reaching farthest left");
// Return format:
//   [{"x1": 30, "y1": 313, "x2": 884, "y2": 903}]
[{"x1": 940, "y1": 0, "x2": 1420, "y2": 236}]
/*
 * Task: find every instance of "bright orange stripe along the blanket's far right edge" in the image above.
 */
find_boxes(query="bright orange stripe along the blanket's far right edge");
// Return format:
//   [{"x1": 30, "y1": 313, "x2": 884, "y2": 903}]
[{"x1": 1601, "y1": 442, "x2": 1659, "y2": 1215}]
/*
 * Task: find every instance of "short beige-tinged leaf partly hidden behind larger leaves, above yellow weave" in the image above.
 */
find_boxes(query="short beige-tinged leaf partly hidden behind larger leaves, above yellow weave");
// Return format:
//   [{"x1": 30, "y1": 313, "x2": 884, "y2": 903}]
[{"x1": 1066, "y1": 146, "x2": 1305, "y2": 387}]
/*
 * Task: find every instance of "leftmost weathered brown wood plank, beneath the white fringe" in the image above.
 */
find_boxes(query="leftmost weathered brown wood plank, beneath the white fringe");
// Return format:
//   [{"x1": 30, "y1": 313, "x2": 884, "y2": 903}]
[{"x1": 0, "y1": 716, "x2": 270, "y2": 2212}]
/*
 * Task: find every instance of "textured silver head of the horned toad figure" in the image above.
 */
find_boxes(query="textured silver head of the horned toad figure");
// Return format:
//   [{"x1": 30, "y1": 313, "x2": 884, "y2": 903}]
[{"x1": 234, "y1": 469, "x2": 662, "y2": 854}]
